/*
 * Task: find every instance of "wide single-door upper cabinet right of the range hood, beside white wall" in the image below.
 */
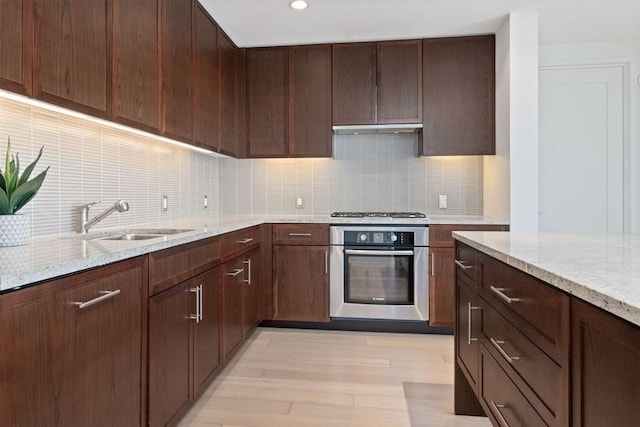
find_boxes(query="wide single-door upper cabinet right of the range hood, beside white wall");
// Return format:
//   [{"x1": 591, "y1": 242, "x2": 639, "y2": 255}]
[{"x1": 422, "y1": 35, "x2": 495, "y2": 156}]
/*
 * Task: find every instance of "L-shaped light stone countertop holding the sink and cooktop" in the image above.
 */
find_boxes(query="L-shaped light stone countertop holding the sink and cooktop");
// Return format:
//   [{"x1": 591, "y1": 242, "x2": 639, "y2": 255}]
[{"x1": 0, "y1": 215, "x2": 506, "y2": 293}]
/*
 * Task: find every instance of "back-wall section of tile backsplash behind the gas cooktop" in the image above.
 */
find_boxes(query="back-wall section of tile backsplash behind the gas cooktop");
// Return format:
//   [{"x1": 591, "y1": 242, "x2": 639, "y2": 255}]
[{"x1": 221, "y1": 134, "x2": 483, "y2": 215}]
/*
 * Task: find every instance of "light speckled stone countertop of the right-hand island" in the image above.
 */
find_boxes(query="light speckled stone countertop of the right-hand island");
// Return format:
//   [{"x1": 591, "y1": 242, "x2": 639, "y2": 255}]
[{"x1": 453, "y1": 231, "x2": 640, "y2": 326}]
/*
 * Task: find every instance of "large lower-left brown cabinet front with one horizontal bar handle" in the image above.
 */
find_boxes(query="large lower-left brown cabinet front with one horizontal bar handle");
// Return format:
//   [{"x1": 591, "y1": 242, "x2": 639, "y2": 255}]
[{"x1": 0, "y1": 257, "x2": 147, "y2": 426}]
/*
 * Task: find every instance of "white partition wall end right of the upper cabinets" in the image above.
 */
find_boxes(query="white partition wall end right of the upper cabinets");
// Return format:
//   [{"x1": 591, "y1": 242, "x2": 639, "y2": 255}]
[{"x1": 484, "y1": 12, "x2": 538, "y2": 231}]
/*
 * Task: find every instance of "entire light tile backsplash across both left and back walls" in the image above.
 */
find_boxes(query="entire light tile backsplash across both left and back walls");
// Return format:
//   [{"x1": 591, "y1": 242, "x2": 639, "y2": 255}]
[{"x1": 0, "y1": 98, "x2": 483, "y2": 236}]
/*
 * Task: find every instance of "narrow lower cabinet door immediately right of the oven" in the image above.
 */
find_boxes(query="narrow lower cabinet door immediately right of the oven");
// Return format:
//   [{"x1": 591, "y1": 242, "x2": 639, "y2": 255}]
[{"x1": 429, "y1": 248, "x2": 456, "y2": 327}]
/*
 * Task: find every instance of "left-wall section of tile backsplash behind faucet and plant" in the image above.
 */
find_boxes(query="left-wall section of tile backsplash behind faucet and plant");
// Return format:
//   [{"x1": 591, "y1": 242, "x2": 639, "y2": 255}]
[{"x1": 0, "y1": 98, "x2": 220, "y2": 236}]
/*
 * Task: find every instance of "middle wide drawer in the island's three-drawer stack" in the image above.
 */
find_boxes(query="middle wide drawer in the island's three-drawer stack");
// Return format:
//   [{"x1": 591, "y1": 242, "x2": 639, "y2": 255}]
[{"x1": 482, "y1": 306, "x2": 569, "y2": 425}]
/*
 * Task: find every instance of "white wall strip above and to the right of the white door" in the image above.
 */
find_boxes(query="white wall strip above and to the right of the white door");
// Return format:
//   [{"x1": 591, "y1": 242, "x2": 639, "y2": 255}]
[{"x1": 540, "y1": 40, "x2": 640, "y2": 233}]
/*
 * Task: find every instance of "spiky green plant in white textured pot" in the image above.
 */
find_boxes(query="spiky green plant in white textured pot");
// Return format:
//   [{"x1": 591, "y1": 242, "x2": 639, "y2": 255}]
[{"x1": 0, "y1": 138, "x2": 49, "y2": 246}]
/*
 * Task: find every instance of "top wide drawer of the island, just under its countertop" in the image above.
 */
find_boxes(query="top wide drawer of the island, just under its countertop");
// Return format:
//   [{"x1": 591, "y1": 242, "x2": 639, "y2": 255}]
[{"x1": 480, "y1": 254, "x2": 569, "y2": 365}]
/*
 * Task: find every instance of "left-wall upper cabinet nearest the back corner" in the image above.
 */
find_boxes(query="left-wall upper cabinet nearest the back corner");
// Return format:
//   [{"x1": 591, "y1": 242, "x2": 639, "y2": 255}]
[{"x1": 217, "y1": 29, "x2": 246, "y2": 158}]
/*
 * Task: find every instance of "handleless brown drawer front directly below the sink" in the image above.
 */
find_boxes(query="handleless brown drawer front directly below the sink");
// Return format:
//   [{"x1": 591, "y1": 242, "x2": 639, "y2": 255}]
[{"x1": 149, "y1": 237, "x2": 220, "y2": 295}]
